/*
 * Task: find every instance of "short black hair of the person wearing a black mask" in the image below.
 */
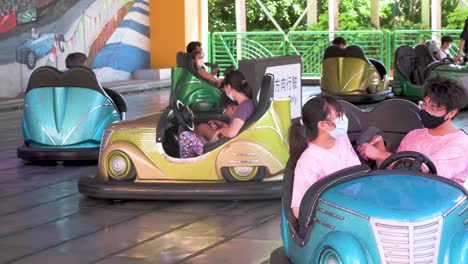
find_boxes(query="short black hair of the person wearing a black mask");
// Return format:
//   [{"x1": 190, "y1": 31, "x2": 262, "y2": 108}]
[{"x1": 424, "y1": 75, "x2": 468, "y2": 112}]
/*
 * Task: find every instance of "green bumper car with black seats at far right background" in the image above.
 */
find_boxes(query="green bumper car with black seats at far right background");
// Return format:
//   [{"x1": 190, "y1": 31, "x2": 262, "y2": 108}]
[{"x1": 392, "y1": 44, "x2": 468, "y2": 107}]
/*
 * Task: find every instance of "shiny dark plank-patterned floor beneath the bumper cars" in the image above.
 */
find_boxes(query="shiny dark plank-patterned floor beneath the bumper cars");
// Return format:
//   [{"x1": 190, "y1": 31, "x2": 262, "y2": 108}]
[{"x1": 0, "y1": 88, "x2": 468, "y2": 264}]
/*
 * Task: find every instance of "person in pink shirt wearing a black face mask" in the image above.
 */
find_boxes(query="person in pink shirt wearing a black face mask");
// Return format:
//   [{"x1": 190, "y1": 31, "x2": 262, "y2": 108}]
[{"x1": 358, "y1": 77, "x2": 468, "y2": 184}]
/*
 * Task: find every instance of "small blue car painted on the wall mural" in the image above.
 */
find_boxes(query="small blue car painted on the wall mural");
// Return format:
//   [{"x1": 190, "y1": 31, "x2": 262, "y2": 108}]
[{"x1": 16, "y1": 33, "x2": 56, "y2": 70}]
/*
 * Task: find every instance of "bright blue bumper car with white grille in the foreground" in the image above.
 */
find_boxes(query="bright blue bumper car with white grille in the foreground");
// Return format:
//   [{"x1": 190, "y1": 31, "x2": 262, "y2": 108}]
[{"x1": 270, "y1": 100, "x2": 468, "y2": 264}]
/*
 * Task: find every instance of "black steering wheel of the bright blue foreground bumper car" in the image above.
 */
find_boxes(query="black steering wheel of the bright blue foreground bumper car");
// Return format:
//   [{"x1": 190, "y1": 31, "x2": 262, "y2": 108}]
[{"x1": 379, "y1": 151, "x2": 437, "y2": 174}]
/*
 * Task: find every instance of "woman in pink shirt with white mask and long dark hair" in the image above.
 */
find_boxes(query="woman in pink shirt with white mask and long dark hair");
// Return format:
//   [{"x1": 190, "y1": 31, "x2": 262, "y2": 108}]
[{"x1": 289, "y1": 96, "x2": 360, "y2": 218}]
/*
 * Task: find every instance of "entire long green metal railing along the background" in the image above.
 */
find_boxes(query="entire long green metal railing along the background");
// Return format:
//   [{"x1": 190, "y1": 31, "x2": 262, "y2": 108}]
[{"x1": 209, "y1": 30, "x2": 461, "y2": 76}]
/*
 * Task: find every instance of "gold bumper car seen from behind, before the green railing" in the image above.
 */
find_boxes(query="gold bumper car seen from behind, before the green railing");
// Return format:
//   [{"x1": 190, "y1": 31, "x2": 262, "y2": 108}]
[{"x1": 320, "y1": 45, "x2": 391, "y2": 103}]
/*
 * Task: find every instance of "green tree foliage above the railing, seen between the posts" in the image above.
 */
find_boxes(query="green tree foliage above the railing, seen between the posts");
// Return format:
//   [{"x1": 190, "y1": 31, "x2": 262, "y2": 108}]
[{"x1": 208, "y1": 0, "x2": 468, "y2": 32}]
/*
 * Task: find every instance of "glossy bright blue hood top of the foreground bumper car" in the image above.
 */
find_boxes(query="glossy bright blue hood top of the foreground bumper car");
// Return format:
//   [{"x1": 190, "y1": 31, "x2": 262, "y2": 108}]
[{"x1": 321, "y1": 174, "x2": 465, "y2": 221}]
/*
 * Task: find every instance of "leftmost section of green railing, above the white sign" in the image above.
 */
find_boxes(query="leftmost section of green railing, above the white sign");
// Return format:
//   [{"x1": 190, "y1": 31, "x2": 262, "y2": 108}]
[{"x1": 211, "y1": 31, "x2": 286, "y2": 72}]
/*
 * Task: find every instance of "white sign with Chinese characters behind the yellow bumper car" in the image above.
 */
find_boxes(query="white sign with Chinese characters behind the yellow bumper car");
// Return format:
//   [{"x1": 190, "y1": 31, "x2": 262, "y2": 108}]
[{"x1": 265, "y1": 63, "x2": 302, "y2": 118}]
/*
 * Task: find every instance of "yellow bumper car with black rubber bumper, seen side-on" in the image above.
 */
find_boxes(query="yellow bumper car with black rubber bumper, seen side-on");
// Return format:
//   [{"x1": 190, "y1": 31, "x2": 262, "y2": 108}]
[{"x1": 78, "y1": 75, "x2": 291, "y2": 200}]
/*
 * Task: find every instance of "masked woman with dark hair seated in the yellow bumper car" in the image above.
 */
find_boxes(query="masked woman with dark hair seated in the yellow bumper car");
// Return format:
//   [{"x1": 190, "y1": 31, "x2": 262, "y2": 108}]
[{"x1": 179, "y1": 70, "x2": 255, "y2": 158}]
